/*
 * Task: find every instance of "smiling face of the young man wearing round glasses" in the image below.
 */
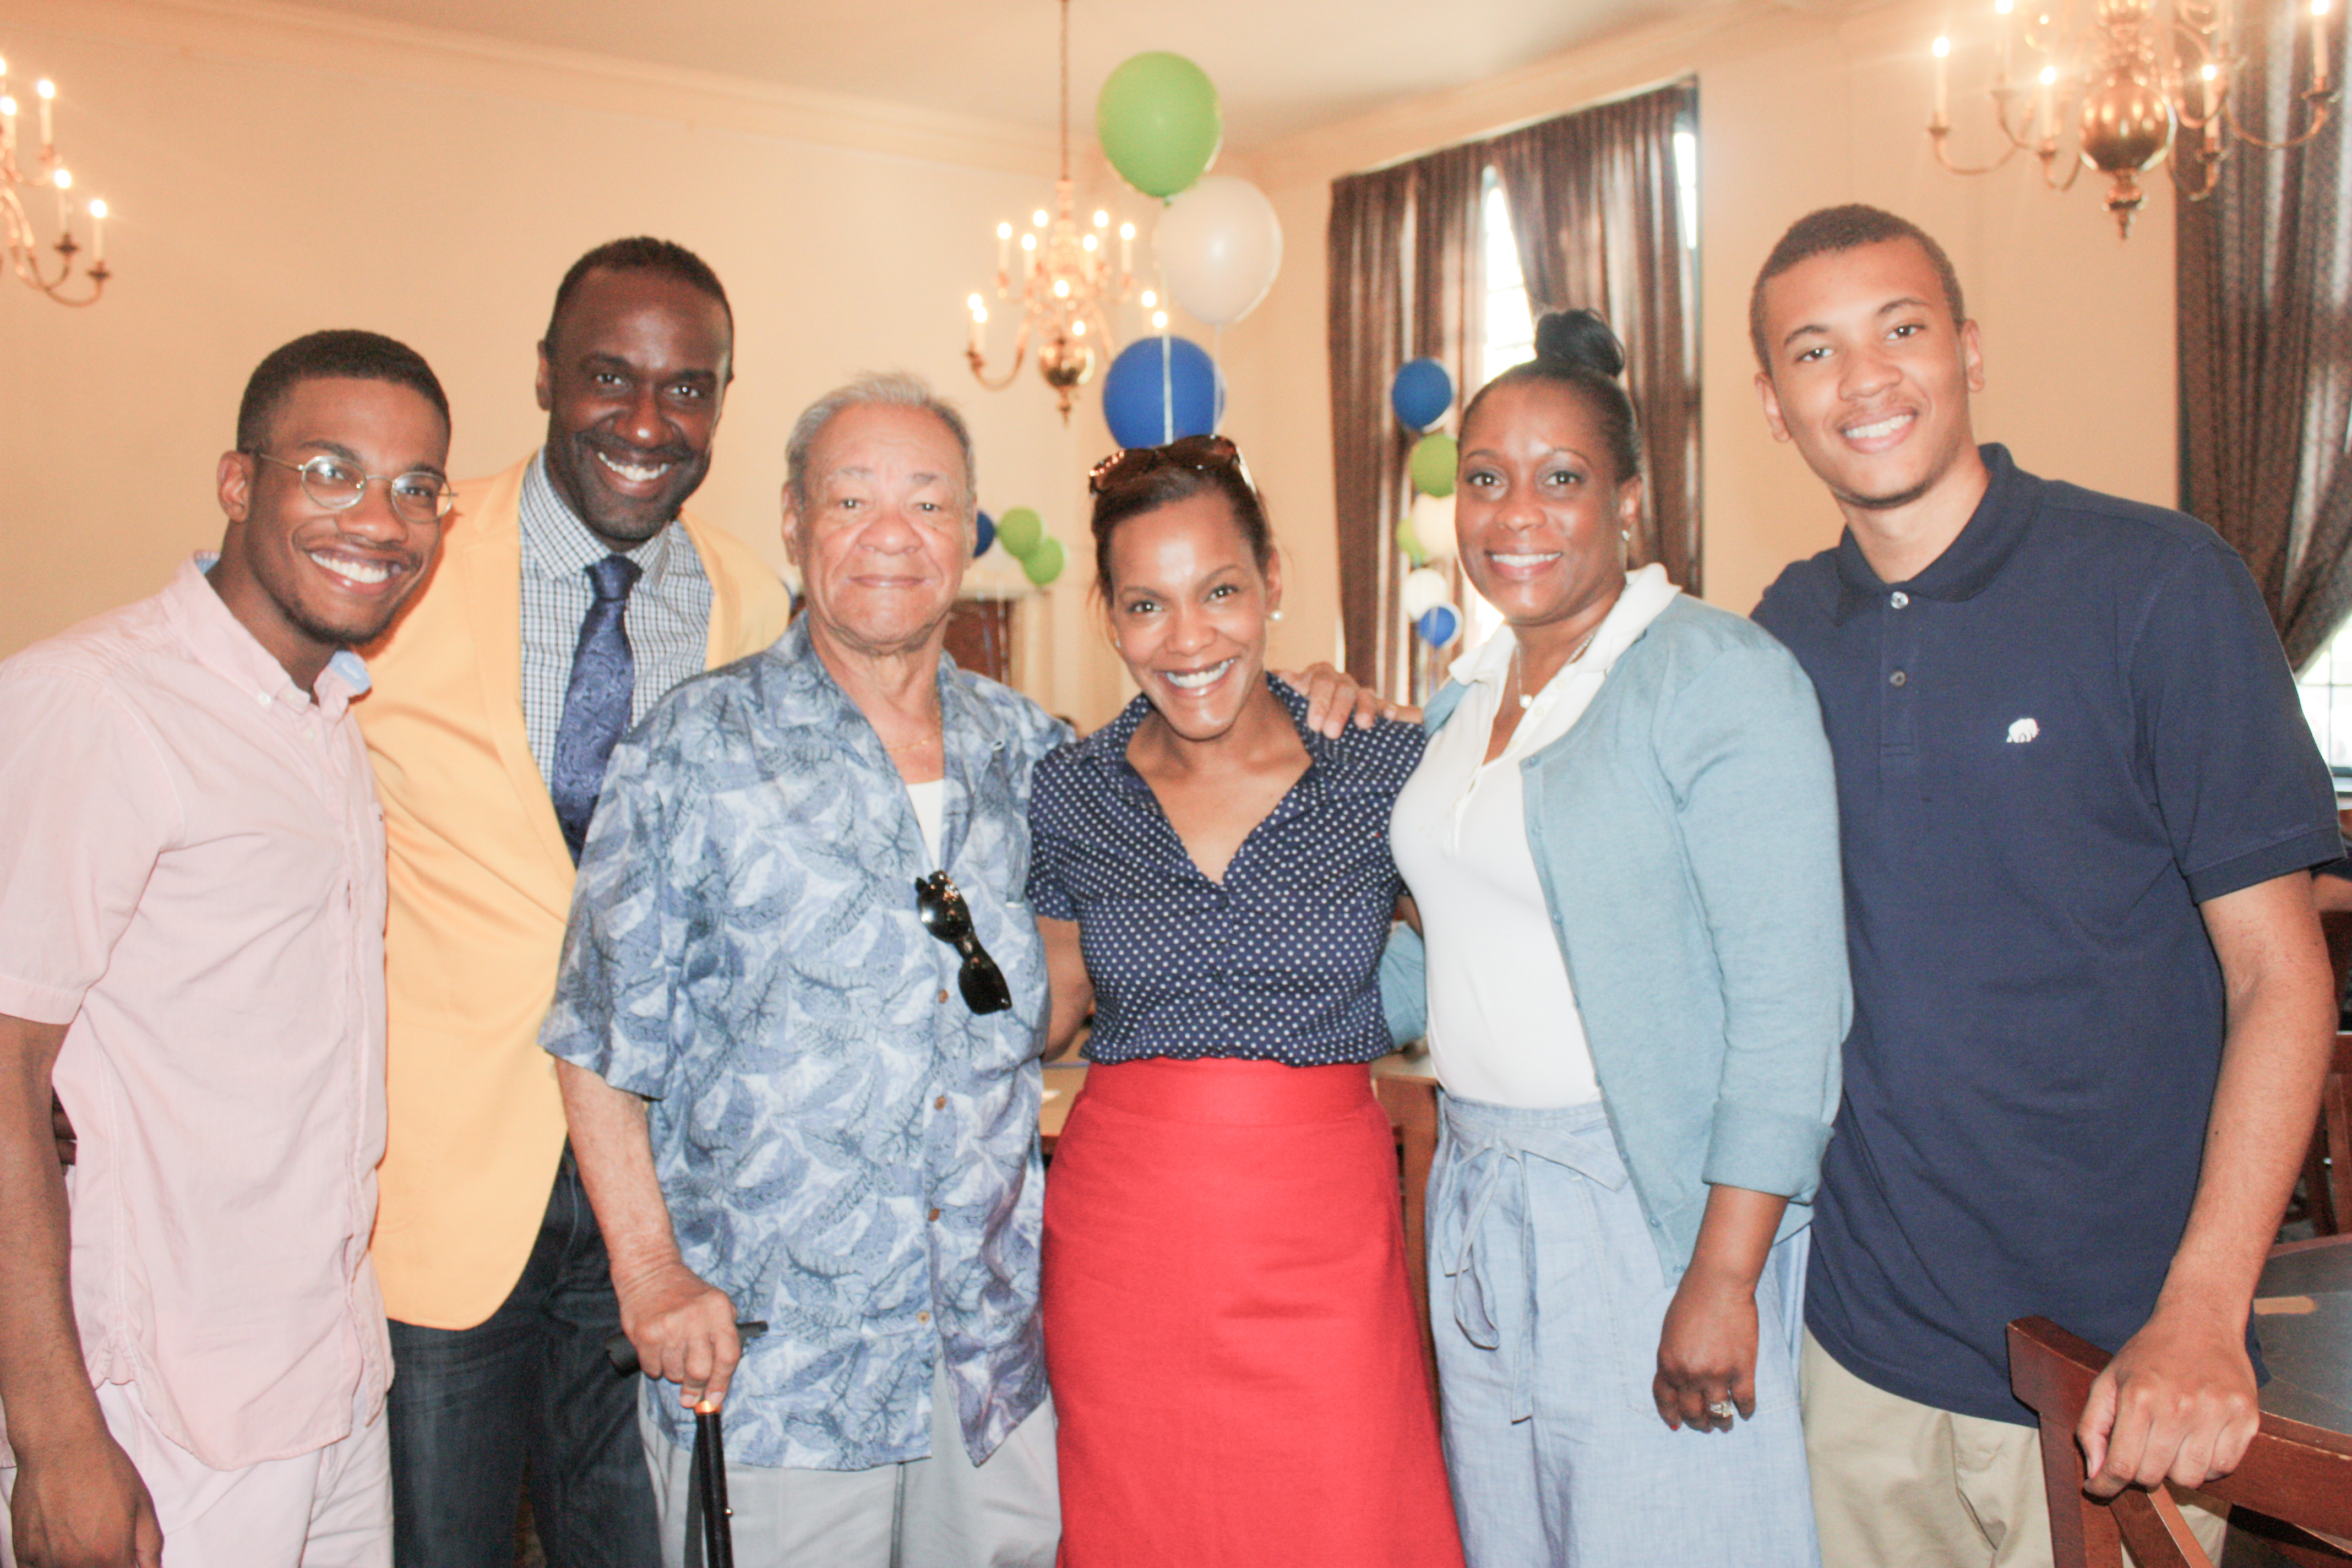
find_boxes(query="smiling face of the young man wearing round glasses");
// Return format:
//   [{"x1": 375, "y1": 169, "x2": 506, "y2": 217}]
[{"x1": 209, "y1": 376, "x2": 449, "y2": 691}]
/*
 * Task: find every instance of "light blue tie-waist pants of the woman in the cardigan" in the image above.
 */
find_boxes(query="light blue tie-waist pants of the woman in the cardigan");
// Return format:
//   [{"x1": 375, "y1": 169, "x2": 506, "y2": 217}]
[{"x1": 1430, "y1": 1096, "x2": 1821, "y2": 1568}]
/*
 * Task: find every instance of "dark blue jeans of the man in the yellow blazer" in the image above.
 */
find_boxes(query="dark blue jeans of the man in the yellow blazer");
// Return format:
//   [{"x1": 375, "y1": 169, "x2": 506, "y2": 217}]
[{"x1": 390, "y1": 1147, "x2": 661, "y2": 1568}]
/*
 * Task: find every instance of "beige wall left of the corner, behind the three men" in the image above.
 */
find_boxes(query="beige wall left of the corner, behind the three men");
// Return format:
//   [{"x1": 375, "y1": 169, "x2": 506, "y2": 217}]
[{"x1": 0, "y1": 0, "x2": 1141, "y2": 722}]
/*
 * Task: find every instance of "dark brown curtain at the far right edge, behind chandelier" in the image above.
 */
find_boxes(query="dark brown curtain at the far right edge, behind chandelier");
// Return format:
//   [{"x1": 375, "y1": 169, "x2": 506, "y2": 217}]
[{"x1": 2176, "y1": 9, "x2": 2352, "y2": 668}]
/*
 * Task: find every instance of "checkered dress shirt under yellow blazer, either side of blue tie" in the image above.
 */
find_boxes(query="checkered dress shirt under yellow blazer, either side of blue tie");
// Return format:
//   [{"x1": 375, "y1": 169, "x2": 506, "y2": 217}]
[{"x1": 522, "y1": 451, "x2": 710, "y2": 778}]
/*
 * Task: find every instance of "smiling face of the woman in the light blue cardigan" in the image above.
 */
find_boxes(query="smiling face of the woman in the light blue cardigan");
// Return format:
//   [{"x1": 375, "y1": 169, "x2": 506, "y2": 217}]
[{"x1": 1453, "y1": 378, "x2": 1642, "y2": 642}]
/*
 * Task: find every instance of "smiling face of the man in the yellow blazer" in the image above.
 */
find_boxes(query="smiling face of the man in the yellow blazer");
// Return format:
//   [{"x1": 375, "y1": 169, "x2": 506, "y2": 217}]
[{"x1": 538, "y1": 268, "x2": 734, "y2": 550}]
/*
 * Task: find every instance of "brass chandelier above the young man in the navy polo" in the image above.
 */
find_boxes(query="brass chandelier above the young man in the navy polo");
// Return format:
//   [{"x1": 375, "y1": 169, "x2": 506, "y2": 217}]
[{"x1": 1926, "y1": 0, "x2": 2338, "y2": 237}]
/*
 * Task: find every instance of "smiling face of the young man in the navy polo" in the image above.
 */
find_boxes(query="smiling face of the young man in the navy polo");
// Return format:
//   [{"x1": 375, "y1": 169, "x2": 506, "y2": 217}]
[{"x1": 1757, "y1": 240, "x2": 1985, "y2": 526}]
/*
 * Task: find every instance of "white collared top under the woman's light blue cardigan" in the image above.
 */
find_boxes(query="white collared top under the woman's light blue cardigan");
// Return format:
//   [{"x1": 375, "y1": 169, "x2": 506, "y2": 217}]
[{"x1": 1387, "y1": 564, "x2": 1681, "y2": 1109}]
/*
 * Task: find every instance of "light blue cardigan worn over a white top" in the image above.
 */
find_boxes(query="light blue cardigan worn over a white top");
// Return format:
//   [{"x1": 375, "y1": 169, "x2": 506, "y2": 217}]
[{"x1": 1381, "y1": 597, "x2": 1853, "y2": 1281}]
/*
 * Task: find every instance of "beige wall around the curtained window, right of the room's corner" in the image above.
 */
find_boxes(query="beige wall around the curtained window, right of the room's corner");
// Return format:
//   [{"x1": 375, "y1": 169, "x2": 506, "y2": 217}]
[{"x1": 1228, "y1": 2, "x2": 2176, "y2": 630}]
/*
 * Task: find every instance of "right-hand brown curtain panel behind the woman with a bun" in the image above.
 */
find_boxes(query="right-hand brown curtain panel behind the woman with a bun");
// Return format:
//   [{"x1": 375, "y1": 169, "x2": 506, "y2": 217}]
[{"x1": 1487, "y1": 82, "x2": 1701, "y2": 592}]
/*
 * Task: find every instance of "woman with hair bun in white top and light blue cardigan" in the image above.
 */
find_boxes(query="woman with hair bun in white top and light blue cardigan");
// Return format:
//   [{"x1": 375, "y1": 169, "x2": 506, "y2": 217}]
[{"x1": 1385, "y1": 311, "x2": 1849, "y2": 1568}]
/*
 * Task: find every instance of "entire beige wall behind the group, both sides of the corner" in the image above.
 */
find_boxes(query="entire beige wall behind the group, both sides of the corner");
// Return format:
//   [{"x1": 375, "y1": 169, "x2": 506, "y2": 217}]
[{"x1": 0, "y1": 0, "x2": 2173, "y2": 724}]
